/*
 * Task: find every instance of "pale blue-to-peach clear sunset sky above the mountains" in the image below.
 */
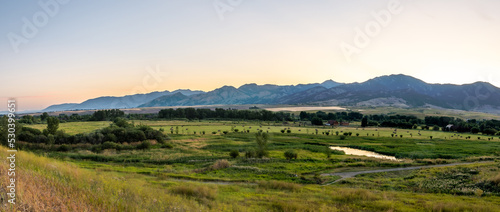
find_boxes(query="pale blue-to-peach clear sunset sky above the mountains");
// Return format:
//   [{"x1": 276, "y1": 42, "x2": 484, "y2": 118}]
[{"x1": 0, "y1": 0, "x2": 500, "y2": 111}]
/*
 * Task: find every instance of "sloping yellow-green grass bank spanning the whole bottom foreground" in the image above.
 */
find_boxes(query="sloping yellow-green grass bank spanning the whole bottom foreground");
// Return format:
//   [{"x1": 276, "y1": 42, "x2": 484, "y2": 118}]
[{"x1": 0, "y1": 145, "x2": 500, "y2": 211}]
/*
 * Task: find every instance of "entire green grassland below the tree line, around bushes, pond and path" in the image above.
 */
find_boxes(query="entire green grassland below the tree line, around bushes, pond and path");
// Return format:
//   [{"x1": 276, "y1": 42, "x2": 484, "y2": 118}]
[{"x1": 0, "y1": 120, "x2": 500, "y2": 211}]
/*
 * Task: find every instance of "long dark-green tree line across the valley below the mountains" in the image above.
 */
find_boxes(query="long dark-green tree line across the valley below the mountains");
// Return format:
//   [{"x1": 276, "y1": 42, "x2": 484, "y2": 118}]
[{"x1": 6, "y1": 108, "x2": 500, "y2": 135}]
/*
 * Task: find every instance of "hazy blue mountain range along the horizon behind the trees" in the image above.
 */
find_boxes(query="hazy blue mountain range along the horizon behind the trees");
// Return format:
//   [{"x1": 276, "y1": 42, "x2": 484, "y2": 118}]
[{"x1": 44, "y1": 74, "x2": 500, "y2": 113}]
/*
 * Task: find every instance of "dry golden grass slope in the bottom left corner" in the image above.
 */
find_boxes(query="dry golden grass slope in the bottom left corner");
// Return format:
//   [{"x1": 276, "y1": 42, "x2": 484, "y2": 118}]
[{"x1": 0, "y1": 147, "x2": 208, "y2": 211}]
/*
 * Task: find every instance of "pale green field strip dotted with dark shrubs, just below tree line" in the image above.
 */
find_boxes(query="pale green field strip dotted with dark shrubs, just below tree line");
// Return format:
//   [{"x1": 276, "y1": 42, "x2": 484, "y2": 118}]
[{"x1": 28, "y1": 120, "x2": 500, "y2": 141}]
